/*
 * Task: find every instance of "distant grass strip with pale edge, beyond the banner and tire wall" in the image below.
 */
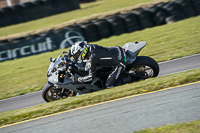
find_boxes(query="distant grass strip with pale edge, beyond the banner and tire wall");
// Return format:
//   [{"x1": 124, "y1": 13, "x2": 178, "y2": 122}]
[{"x1": 0, "y1": 0, "x2": 170, "y2": 39}]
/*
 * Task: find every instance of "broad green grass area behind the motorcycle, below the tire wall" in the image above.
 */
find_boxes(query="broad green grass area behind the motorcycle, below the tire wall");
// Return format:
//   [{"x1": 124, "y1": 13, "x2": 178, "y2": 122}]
[{"x1": 0, "y1": 16, "x2": 200, "y2": 99}]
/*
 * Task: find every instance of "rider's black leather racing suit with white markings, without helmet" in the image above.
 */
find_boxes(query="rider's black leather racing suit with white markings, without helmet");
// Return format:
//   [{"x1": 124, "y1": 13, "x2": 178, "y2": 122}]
[{"x1": 78, "y1": 45, "x2": 126, "y2": 87}]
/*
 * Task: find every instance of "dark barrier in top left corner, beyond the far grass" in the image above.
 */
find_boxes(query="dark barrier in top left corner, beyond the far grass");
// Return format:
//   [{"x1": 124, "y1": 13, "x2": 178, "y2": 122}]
[{"x1": 0, "y1": 0, "x2": 80, "y2": 27}]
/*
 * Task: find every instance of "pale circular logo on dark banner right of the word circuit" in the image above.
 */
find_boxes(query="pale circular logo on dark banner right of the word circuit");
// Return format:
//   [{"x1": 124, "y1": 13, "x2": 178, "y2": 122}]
[{"x1": 60, "y1": 31, "x2": 84, "y2": 49}]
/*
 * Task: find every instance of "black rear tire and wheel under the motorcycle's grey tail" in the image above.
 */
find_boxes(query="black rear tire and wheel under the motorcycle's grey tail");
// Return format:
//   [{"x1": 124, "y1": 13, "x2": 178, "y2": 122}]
[{"x1": 126, "y1": 56, "x2": 160, "y2": 78}]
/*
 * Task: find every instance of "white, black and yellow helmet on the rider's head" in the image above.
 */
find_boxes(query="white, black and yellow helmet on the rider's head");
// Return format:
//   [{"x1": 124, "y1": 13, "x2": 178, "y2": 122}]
[{"x1": 71, "y1": 41, "x2": 88, "y2": 61}]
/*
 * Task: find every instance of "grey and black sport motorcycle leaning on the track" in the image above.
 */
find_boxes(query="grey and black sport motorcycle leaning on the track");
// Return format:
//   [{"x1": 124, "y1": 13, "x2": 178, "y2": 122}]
[{"x1": 42, "y1": 41, "x2": 159, "y2": 102}]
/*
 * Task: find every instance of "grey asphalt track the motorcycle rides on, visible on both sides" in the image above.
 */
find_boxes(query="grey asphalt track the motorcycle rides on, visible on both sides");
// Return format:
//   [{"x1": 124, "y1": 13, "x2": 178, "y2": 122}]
[{"x1": 0, "y1": 54, "x2": 200, "y2": 113}]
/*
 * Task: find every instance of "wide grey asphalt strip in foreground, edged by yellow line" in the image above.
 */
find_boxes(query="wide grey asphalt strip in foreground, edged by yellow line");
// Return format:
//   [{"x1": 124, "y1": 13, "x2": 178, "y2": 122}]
[{"x1": 0, "y1": 82, "x2": 200, "y2": 133}]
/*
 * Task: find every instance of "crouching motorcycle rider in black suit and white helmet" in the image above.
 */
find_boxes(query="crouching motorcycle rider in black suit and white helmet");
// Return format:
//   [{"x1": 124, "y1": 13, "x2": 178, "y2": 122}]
[{"x1": 71, "y1": 41, "x2": 126, "y2": 88}]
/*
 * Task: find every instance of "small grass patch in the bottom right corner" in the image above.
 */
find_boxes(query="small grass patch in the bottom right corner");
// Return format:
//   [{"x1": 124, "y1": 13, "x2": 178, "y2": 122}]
[{"x1": 134, "y1": 120, "x2": 200, "y2": 133}]
